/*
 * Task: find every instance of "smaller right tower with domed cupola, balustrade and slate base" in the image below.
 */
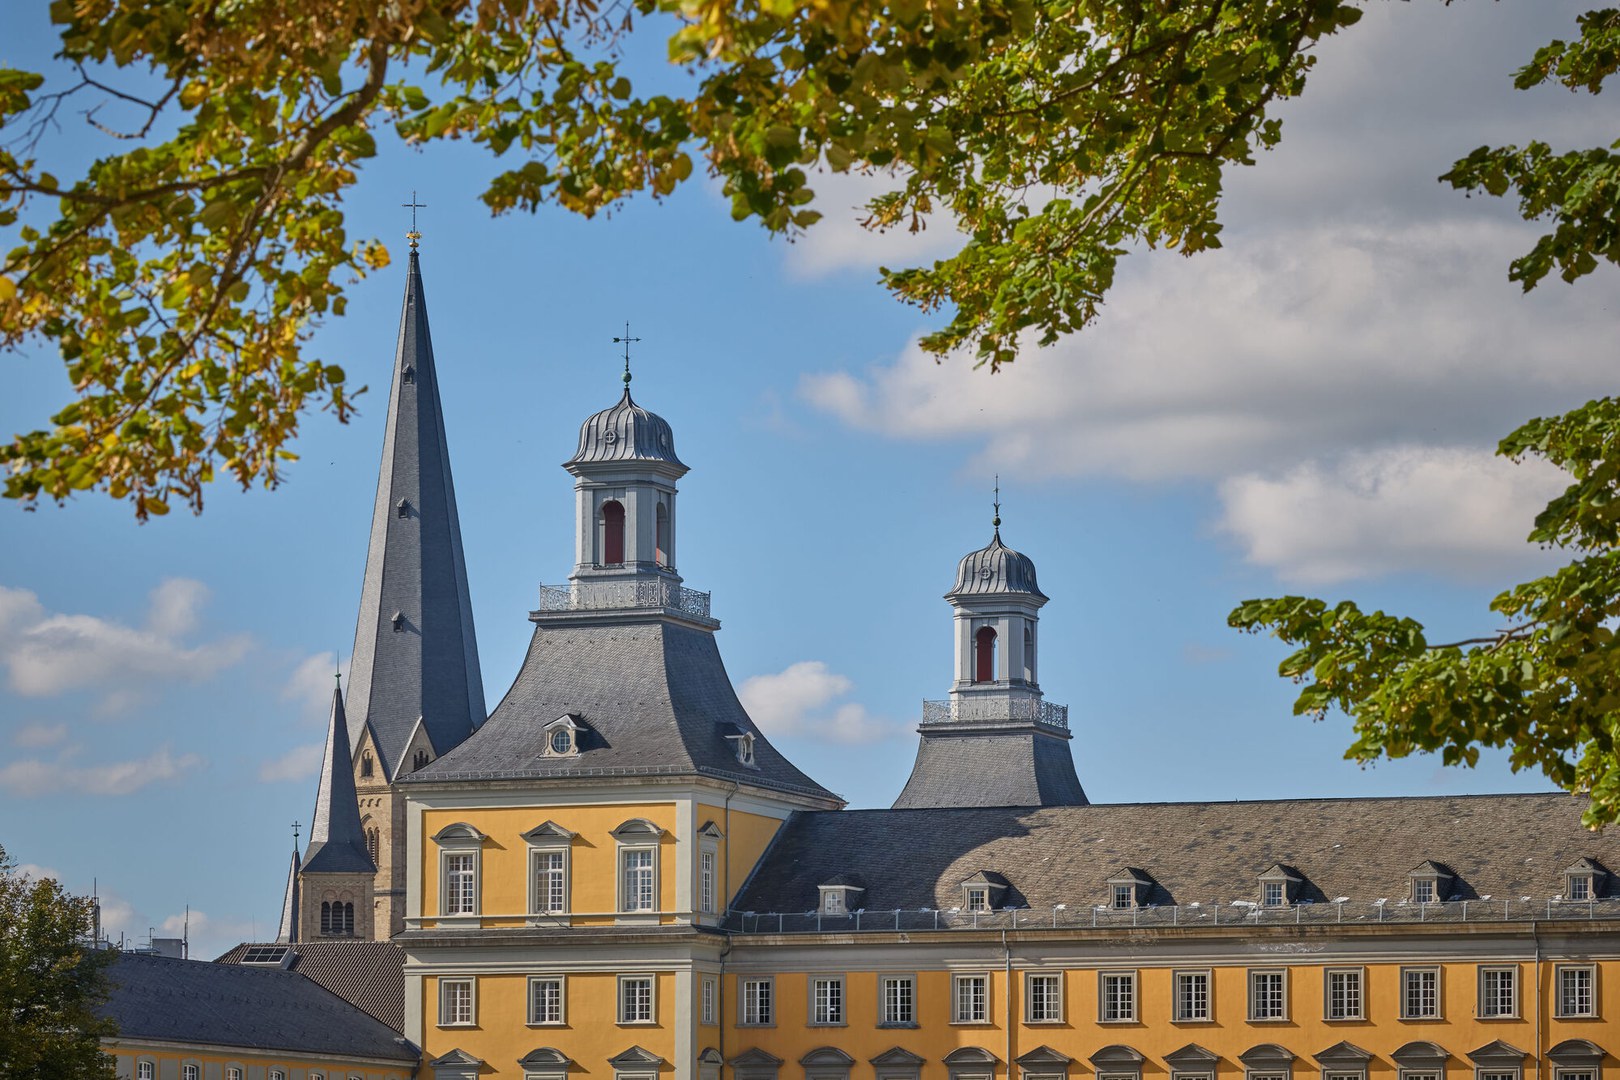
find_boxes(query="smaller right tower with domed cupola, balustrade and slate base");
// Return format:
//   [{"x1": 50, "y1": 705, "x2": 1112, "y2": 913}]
[{"x1": 894, "y1": 502, "x2": 1087, "y2": 810}]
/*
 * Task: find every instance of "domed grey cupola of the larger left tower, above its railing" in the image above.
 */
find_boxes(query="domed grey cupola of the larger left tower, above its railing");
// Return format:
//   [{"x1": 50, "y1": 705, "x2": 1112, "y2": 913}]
[{"x1": 562, "y1": 371, "x2": 687, "y2": 583}]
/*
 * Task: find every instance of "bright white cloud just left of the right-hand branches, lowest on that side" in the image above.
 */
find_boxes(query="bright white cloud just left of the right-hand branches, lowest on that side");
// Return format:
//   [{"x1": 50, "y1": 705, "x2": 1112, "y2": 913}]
[{"x1": 1220, "y1": 447, "x2": 1568, "y2": 585}]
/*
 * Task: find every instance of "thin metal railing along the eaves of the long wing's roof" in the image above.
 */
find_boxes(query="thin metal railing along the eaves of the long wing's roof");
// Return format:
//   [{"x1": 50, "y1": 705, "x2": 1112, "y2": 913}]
[{"x1": 723, "y1": 897, "x2": 1620, "y2": 934}]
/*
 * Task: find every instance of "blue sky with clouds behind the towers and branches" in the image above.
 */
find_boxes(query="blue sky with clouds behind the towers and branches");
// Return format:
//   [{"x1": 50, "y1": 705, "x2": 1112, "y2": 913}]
[{"x1": 0, "y1": 0, "x2": 1620, "y2": 955}]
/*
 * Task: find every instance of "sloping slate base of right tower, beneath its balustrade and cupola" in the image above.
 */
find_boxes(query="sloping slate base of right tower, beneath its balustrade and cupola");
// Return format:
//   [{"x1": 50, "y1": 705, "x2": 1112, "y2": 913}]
[{"x1": 894, "y1": 724, "x2": 1087, "y2": 810}]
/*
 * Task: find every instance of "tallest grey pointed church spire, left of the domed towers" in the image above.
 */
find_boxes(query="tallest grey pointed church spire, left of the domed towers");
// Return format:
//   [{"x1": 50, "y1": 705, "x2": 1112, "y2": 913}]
[{"x1": 348, "y1": 248, "x2": 486, "y2": 780}]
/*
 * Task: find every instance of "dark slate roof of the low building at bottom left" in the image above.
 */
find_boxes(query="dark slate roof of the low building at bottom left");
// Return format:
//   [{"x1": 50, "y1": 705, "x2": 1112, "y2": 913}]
[{"x1": 102, "y1": 954, "x2": 418, "y2": 1062}]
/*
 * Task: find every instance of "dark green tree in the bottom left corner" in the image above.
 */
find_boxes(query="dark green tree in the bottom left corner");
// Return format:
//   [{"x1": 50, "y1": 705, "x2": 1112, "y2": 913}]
[{"x1": 0, "y1": 847, "x2": 117, "y2": 1080}]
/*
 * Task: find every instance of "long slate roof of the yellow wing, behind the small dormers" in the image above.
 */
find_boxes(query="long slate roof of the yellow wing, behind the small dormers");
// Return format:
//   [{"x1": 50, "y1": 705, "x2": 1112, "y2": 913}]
[{"x1": 732, "y1": 793, "x2": 1620, "y2": 912}]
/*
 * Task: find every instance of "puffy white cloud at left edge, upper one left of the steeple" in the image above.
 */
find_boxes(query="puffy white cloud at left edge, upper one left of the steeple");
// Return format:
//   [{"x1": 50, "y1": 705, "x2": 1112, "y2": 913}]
[{"x1": 0, "y1": 578, "x2": 253, "y2": 711}]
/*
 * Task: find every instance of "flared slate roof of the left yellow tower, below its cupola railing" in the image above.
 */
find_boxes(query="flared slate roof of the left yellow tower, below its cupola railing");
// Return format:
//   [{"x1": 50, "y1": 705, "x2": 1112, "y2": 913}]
[{"x1": 405, "y1": 612, "x2": 841, "y2": 801}]
